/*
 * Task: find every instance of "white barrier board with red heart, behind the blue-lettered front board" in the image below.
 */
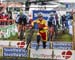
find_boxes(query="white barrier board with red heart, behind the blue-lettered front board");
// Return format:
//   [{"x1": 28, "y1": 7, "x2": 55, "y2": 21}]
[{"x1": 0, "y1": 41, "x2": 27, "y2": 48}]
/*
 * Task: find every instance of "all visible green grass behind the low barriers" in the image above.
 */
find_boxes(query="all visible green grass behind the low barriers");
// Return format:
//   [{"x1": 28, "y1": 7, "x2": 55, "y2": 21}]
[{"x1": 0, "y1": 30, "x2": 72, "y2": 42}]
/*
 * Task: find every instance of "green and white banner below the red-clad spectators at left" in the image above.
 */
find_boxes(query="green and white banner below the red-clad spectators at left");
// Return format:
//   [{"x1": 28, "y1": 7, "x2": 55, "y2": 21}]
[{"x1": 0, "y1": 24, "x2": 17, "y2": 38}]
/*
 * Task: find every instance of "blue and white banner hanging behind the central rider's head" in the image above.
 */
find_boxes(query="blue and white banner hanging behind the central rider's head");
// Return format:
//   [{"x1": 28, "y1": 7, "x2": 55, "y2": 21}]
[{"x1": 33, "y1": 10, "x2": 56, "y2": 20}]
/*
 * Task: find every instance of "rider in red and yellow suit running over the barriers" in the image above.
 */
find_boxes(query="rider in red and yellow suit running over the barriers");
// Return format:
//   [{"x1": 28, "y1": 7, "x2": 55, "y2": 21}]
[{"x1": 32, "y1": 14, "x2": 48, "y2": 49}]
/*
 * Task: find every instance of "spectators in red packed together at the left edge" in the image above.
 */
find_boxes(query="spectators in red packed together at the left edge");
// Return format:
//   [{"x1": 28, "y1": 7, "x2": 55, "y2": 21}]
[{"x1": 0, "y1": 11, "x2": 13, "y2": 25}]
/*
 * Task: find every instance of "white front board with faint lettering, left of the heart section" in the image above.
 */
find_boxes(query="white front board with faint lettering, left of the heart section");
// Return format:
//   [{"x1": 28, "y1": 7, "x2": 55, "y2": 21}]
[{"x1": 30, "y1": 49, "x2": 52, "y2": 59}]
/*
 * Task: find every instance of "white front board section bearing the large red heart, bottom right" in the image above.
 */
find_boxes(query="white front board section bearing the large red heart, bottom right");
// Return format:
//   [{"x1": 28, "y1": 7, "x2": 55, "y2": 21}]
[{"x1": 54, "y1": 50, "x2": 75, "y2": 60}]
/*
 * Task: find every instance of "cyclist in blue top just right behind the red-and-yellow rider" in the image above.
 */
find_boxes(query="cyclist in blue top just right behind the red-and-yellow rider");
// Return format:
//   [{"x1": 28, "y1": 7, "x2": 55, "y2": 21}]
[{"x1": 48, "y1": 13, "x2": 55, "y2": 41}]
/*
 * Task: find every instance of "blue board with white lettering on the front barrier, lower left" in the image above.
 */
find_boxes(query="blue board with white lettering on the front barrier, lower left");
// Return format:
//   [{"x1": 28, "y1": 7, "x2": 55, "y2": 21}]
[{"x1": 3, "y1": 48, "x2": 28, "y2": 57}]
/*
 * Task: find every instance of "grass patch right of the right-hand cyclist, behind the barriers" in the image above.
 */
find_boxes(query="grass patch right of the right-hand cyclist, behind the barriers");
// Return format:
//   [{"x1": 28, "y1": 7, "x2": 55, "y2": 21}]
[{"x1": 56, "y1": 30, "x2": 72, "y2": 42}]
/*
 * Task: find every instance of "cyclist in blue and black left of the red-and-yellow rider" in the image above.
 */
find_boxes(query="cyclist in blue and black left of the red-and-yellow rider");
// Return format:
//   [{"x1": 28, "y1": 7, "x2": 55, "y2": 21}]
[{"x1": 16, "y1": 11, "x2": 28, "y2": 38}]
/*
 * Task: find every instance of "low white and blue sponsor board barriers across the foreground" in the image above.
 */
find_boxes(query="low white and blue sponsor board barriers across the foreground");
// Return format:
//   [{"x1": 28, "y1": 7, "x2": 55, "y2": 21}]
[{"x1": 0, "y1": 41, "x2": 75, "y2": 60}]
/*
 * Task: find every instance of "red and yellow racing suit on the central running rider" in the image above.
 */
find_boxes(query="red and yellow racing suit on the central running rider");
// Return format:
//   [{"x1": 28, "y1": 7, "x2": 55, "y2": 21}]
[{"x1": 32, "y1": 19, "x2": 48, "y2": 41}]
